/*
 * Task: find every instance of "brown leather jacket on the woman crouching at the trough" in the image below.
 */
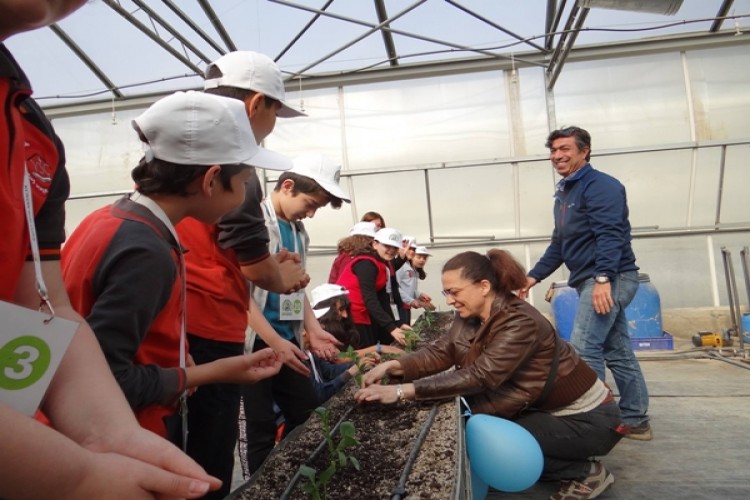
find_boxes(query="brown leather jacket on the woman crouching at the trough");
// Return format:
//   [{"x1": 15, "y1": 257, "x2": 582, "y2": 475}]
[{"x1": 400, "y1": 295, "x2": 596, "y2": 418}]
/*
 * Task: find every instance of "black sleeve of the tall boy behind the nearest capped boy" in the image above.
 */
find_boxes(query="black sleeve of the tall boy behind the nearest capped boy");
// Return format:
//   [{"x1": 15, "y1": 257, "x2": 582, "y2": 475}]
[{"x1": 218, "y1": 171, "x2": 269, "y2": 264}]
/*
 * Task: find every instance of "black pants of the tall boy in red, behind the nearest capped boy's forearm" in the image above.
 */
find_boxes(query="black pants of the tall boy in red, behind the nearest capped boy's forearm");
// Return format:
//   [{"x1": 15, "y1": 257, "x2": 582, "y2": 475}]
[{"x1": 187, "y1": 335, "x2": 244, "y2": 499}]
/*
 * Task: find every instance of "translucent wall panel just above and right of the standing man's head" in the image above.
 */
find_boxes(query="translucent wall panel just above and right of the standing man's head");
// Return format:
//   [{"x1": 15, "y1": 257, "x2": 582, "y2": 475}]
[{"x1": 554, "y1": 53, "x2": 691, "y2": 152}]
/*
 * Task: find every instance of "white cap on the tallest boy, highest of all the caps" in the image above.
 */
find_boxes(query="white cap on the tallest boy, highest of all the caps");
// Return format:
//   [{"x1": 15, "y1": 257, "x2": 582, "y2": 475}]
[{"x1": 203, "y1": 50, "x2": 307, "y2": 118}]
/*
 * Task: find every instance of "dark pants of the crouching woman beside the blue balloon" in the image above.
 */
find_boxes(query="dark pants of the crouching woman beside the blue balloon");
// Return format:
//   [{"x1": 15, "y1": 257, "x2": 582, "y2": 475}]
[{"x1": 515, "y1": 401, "x2": 622, "y2": 481}]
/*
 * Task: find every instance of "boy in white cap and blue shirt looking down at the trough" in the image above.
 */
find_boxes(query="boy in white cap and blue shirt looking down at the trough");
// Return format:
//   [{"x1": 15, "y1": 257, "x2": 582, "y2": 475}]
[{"x1": 242, "y1": 154, "x2": 349, "y2": 472}]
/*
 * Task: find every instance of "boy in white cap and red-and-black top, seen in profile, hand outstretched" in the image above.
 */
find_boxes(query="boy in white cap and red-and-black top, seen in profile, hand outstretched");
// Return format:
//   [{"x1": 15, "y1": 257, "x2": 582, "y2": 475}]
[{"x1": 62, "y1": 92, "x2": 288, "y2": 446}]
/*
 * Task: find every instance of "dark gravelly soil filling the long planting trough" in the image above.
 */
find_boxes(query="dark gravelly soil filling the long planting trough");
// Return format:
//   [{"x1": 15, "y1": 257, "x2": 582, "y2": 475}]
[{"x1": 233, "y1": 313, "x2": 458, "y2": 499}]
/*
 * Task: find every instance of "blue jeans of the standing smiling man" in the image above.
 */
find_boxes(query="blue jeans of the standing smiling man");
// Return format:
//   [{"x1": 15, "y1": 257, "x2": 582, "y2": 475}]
[{"x1": 570, "y1": 271, "x2": 648, "y2": 426}]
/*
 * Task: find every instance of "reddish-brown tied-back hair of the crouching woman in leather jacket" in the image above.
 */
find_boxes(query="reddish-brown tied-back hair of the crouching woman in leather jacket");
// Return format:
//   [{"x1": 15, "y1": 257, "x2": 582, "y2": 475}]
[{"x1": 443, "y1": 248, "x2": 526, "y2": 295}]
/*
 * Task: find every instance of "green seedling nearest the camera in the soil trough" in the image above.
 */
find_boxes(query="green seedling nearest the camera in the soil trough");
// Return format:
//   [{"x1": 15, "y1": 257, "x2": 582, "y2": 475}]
[{"x1": 300, "y1": 408, "x2": 360, "y2": 500}]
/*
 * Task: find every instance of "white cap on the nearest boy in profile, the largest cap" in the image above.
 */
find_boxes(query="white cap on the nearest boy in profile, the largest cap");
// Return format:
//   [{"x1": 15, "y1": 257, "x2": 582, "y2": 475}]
[{"x1": 131, "y1": 90, "x2": 292, "y2": 170}]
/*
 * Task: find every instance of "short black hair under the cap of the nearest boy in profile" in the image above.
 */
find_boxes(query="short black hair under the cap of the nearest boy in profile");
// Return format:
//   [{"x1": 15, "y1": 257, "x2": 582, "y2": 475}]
[{"x1": 130, "y1": 157, "x2": 247, "y2": 196}]
